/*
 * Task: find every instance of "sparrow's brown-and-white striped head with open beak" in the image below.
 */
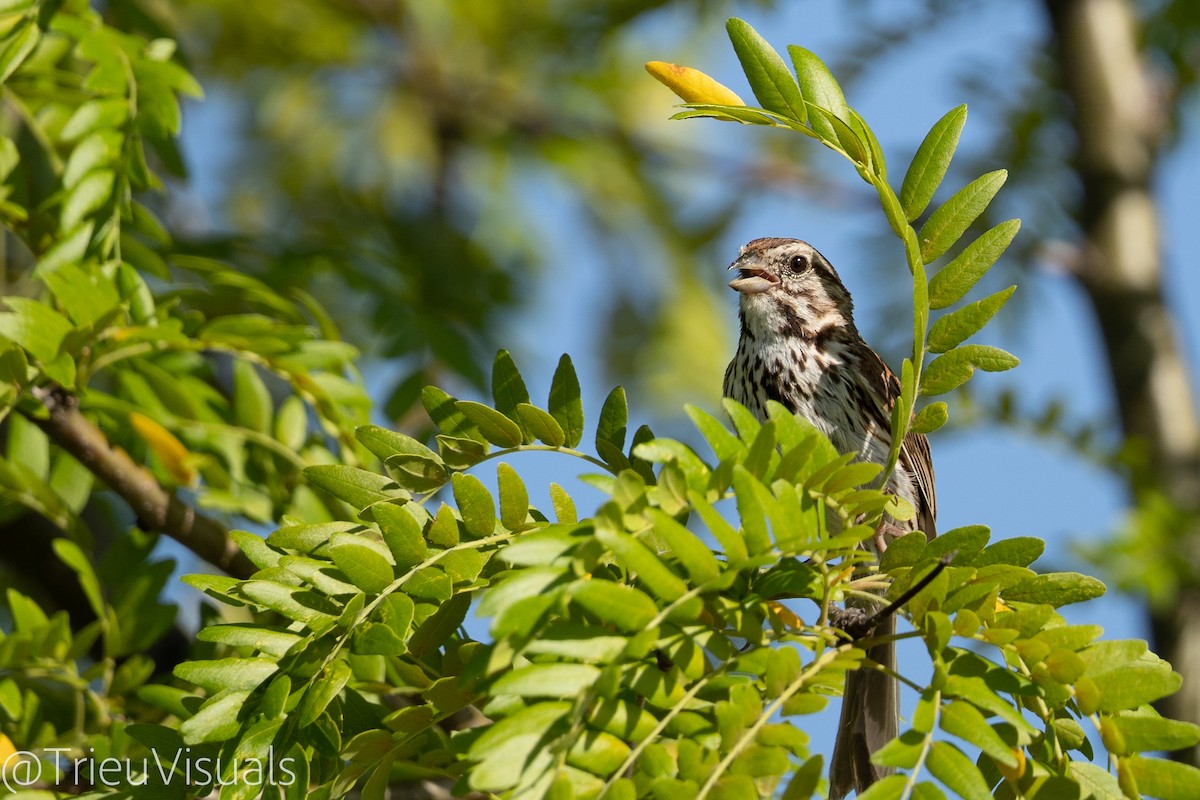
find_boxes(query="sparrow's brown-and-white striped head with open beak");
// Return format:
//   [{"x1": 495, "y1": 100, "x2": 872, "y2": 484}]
[{"x1": 730, "y1": 239, "x2": 853, "y2": 338}]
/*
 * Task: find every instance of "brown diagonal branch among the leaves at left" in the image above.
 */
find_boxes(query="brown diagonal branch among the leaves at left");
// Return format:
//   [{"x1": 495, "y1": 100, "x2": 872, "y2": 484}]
[{"x1": 29, "y1": 390, "x2": 256, "y2": 578}]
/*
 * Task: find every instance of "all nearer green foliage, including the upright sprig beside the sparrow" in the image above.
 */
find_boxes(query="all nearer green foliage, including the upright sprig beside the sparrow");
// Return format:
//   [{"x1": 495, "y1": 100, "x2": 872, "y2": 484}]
[{"x1": 0, "y1": 9, "x2": 1200, "y2": 800}]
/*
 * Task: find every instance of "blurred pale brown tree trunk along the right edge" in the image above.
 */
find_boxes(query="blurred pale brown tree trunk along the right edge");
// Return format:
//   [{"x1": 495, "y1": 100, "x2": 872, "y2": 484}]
[{"x1": 1045, "y1": 0, "x2": 1200, "y2": 765}]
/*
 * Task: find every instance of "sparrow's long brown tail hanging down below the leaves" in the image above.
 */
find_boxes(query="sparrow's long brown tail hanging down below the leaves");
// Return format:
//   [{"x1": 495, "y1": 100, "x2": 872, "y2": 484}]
[{"x1": 829, "y1": 615, "x2": 900, "y2": 800}]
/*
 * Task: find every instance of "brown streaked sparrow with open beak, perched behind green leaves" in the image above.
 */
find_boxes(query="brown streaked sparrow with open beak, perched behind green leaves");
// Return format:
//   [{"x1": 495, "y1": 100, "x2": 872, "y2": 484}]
[{"x1": 725, "y1": 239, "x2": 937, "y2": 798}]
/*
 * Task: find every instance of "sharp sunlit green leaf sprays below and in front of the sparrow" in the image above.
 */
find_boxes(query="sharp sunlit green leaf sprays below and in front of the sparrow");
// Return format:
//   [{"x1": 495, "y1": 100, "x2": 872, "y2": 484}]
[{"x1": 112, "y1": 353, "x2": 1200, "y2": 798}]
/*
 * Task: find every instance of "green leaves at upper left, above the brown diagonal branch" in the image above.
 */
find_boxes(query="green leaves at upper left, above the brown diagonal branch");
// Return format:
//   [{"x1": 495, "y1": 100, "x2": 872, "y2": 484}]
[{"x1": 0, "y1": 2, "x2": 368, "y2": 532}]
